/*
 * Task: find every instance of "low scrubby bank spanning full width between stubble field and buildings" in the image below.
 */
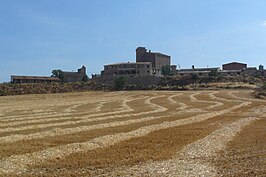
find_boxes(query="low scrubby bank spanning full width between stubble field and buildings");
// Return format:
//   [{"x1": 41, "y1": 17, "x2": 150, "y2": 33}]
[{"x1": 0, "y1": 76, "x2": 266, "y2": 96}]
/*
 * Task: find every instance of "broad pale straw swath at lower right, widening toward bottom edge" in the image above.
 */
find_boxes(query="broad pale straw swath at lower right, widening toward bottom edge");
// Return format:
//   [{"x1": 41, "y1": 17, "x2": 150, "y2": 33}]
[{"x1": 115, "y1": 117, "x2": 258, "y2": 176}]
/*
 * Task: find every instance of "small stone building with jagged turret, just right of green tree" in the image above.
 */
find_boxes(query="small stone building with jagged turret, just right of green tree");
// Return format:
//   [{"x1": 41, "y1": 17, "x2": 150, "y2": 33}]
[{"x1": 61, "y1": 66, "x2": 87, "y2": 82}]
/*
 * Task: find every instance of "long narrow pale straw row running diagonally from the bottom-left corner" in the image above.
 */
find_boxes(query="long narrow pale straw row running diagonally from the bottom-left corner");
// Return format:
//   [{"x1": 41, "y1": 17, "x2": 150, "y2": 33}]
[{"x1": 0, "y1": 102, "x2": 250, "y2": 173}]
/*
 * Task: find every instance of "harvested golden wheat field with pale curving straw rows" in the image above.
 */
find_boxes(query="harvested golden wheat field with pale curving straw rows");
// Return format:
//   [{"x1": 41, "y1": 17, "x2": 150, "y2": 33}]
[{"x1": 0, "y1": 90, "x2": 266, "y2": 176}]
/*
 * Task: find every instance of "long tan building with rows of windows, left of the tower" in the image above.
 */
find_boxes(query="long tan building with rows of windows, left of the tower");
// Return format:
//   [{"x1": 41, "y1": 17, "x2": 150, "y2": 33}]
[{"x1": 101, "y1": 62, "x2": 152, "y2": 76}]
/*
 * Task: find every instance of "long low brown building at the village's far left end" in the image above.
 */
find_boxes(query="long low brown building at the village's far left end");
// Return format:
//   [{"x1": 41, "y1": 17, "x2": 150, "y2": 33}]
[{"x1": 11, "y1": 76, "x2": 60, "y2": 84}]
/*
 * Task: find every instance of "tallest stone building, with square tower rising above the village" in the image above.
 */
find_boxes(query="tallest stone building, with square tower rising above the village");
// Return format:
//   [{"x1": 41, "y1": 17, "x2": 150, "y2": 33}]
[{"x1": 136, "y1": 47, "x2": 171, "y2": 76}]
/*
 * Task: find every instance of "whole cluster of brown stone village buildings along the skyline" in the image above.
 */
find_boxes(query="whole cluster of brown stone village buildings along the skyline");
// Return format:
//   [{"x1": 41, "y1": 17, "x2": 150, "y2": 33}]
[{"x1": 11, "y1": 47, "x2": 266, "y2": 84}]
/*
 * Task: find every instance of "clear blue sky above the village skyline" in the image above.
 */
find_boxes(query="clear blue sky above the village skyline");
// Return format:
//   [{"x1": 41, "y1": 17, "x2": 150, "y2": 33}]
[{"x1": 0, "y1": 0, "x2": 266, "y2": 82}]
